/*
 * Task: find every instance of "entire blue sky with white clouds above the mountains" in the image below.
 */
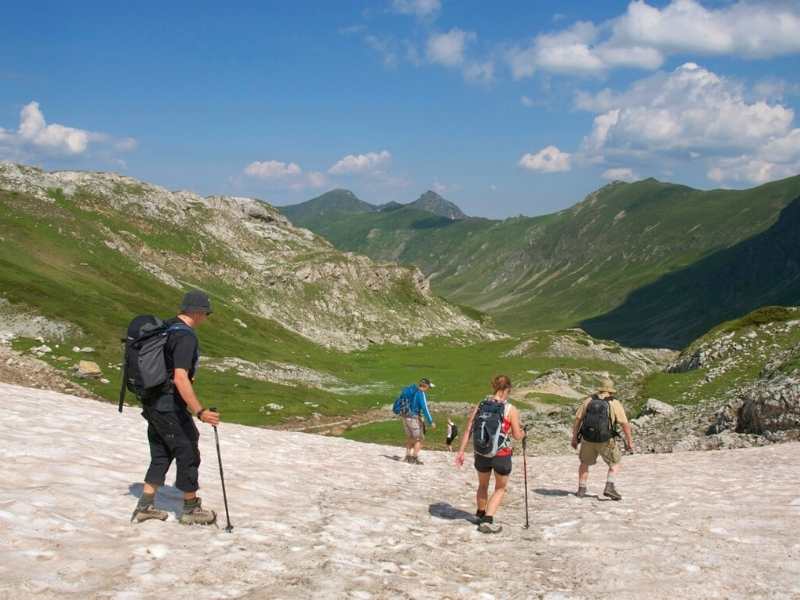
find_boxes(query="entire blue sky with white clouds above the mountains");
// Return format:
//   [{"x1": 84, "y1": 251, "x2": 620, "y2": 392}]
[{"x1": 0, "y1": 0, "x2": 800, "y2": 217}]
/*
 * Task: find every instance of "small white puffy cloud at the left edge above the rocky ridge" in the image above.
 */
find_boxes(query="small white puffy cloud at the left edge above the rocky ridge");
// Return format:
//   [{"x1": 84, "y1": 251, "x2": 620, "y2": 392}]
[{"x1": 0, "y1": 101, "x2": 136, "y2": 161}]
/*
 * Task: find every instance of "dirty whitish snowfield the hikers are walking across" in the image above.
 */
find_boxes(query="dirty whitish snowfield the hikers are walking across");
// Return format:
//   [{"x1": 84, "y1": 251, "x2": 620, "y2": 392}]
[{"x1": 0, "y1": 384, "x2": 800, "y2": 600}]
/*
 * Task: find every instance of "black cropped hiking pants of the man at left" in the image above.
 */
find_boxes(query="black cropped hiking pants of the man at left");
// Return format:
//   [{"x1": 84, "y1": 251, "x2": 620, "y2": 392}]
[{"x1": 142, "y1": 406, "x2": 200, "y2": 492}]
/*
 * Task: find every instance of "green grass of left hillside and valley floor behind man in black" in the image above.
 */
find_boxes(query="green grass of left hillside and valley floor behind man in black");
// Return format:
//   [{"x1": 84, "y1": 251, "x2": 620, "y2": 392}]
[{"x1": 0, "y1": 165, "x2": 648, "y2": 440}]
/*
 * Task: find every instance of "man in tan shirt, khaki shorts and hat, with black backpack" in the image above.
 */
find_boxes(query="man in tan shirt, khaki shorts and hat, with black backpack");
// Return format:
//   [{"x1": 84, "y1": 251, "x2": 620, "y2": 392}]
[{"x1": 572, "y1": 379, "x2": 633, "y2": 500}]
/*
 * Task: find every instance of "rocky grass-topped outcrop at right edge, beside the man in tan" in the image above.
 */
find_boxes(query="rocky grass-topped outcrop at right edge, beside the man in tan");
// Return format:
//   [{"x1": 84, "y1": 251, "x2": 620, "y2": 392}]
[{"x1": 634, "y1": 307, "x2": 800, "y2": 451}]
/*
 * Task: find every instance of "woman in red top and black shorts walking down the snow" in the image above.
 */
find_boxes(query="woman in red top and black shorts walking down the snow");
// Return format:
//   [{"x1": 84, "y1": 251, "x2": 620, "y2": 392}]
[{"x1": 456, "y1": 375, "x2": 525, "y2": 533}]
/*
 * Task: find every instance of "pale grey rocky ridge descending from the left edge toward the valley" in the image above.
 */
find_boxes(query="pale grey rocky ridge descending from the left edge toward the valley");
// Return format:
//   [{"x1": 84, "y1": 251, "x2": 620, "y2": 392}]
[{"x1": 0, "y1": 163, "x2": 495, "y2": 350}]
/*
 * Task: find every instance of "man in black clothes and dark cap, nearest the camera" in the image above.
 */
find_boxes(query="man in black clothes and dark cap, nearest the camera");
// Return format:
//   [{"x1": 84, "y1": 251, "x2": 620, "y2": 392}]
[{"x1": 131, "y1": 290, "x2": 219, "y2": 525}]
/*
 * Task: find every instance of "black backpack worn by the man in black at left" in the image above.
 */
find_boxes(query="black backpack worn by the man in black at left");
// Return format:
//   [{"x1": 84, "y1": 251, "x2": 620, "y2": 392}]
[{"x1": 119, "y1": 315, "x2": 194, "y2": 412}]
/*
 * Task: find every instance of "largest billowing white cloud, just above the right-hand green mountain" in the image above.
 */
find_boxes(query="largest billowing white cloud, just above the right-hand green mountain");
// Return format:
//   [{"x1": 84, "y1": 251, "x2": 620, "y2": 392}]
[{"x1": 576, "y1": 63, "x2": 800, "y2": 183}]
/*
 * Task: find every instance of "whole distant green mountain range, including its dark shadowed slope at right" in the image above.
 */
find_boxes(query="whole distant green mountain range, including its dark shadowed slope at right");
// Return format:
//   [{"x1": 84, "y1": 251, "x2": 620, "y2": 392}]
[{"x1": 281, "y1": 176, "x2": 800, "y2": 348}]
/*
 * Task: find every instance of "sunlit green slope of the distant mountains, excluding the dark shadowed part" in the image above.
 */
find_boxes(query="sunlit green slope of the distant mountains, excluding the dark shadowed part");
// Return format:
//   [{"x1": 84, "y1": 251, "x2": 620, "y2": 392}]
[{"x1": 280, "y1": 176, "x2": 800, "y2": 341}]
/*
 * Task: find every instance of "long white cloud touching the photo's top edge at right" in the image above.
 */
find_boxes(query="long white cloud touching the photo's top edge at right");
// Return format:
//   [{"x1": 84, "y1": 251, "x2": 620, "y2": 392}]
[{"x1": 507, "y1": 0, "x2": 800, "y2": 79}]
